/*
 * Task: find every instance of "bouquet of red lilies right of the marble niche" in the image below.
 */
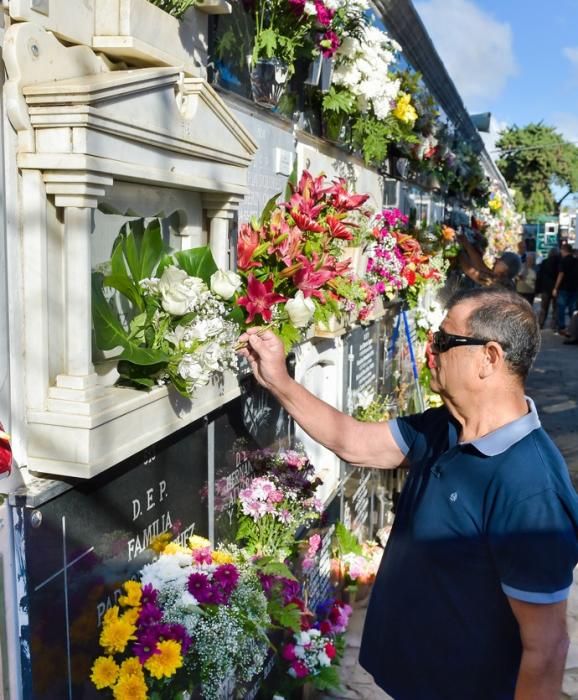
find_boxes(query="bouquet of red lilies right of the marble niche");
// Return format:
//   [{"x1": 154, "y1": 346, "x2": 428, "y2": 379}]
[{"x1": 237, "y1": 171, "x2": 373, "y2": 347}]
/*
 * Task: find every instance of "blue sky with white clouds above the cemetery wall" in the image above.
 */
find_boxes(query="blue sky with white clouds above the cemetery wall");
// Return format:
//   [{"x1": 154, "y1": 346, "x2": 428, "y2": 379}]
[{"x1": 414, "y1": 0, "x2": 578, "y2": 150}]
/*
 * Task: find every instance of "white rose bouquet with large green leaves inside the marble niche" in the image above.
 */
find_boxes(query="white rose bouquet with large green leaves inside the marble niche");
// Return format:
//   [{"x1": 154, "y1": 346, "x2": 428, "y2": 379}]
[{"x1": 93, "y1": 220, "x2": 240, "y2": 397}]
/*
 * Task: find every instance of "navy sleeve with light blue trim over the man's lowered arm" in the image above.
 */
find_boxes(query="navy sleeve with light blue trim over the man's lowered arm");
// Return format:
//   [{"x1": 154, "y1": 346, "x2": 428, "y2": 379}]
[{"x1": 490, "y1": 489, "x2": 578, "y2": 603}]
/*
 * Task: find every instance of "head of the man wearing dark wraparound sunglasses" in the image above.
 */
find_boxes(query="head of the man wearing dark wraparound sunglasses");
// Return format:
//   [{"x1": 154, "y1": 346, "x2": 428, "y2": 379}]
[{"x1": 432, "y1": 287, "x2": 540, "y2": 400}]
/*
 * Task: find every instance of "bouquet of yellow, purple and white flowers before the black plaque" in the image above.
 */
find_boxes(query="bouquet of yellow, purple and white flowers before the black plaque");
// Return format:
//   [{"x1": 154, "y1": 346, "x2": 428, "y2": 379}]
[{"x1": 91, "y1": 538, "x2": 271, "y2": 700}]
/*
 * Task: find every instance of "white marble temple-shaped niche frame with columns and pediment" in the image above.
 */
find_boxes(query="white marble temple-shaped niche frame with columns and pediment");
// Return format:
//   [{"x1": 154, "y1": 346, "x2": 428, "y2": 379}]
[{"x1": 5, "y1": 23, "x2": 257, "y2": 478}]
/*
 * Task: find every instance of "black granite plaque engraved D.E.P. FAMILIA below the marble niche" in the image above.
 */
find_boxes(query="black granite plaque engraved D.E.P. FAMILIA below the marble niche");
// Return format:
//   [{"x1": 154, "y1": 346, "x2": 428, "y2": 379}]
[{"x1": 15, "y1": 424, "x2": 208, "y2": 700}]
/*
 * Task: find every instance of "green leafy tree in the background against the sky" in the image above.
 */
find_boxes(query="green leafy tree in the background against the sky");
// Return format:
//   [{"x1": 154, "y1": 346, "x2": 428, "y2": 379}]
[{"x1": 496, "y1": 122, "x2": 578, "y2": 220}]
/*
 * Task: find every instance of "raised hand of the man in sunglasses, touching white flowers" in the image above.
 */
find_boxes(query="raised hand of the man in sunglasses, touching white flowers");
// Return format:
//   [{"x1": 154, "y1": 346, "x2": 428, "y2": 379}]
[{"x1": 239, "y1": 326, "x2": 289, "y2": 390}]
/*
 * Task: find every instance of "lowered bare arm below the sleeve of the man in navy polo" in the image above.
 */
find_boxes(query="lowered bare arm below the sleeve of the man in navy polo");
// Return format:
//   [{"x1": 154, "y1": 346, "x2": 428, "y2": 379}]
[{"x1": 508, "y1": 597, "x2": 569, "y2": 700}]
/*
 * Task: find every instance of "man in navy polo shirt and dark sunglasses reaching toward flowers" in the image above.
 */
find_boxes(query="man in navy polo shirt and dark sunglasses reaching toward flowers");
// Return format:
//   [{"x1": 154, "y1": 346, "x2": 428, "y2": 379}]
[{"x1": 242, "y1": 287, "x2": 578, "y2": 700}]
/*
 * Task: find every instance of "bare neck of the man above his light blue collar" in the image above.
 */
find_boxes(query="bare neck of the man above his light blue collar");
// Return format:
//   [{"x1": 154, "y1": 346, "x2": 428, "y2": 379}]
[{"x1": 445, "y1": 388, "x2": 528, "y2": 442}]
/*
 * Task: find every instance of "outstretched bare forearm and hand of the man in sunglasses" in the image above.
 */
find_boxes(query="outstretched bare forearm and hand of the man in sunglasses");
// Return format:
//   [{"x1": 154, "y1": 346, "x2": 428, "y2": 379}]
[{"x1": 239, "y1": 328, "x2": 404, "y2": 469}]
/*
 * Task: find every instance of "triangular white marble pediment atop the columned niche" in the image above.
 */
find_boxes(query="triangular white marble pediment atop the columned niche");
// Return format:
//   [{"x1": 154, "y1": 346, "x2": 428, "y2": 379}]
[{"x1": 7, "y1": 27, "x2": 257, "y2": 195}]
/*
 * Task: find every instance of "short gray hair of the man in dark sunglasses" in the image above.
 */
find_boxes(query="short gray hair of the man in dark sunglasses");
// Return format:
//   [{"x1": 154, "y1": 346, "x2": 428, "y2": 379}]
[{"x1": 446, "y1": 287, "x2": 541, "y2": 381}]
